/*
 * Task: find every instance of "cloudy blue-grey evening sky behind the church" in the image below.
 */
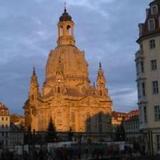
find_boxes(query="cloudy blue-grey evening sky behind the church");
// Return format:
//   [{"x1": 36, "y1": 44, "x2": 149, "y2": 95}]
[{"x1": 0, "y1": 0, "x2": 150, "y2": 113}]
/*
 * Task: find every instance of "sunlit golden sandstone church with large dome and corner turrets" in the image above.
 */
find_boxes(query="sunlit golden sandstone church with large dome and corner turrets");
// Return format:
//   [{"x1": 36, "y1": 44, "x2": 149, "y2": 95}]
[{"x1": 24, "y1": 8, "x2": 112, "y2": 133}]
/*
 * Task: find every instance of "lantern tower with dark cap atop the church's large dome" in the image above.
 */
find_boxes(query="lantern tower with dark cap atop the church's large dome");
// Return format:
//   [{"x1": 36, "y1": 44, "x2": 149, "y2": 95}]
[{"x1": 57, "y1": 7, "x2": 75, "y2": 46}]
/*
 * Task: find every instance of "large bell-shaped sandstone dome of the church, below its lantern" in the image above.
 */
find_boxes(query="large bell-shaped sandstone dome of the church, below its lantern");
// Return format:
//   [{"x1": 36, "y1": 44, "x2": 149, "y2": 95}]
[{"x1": 46, "y1": 46, "x2": 88, "y2": 85}]
